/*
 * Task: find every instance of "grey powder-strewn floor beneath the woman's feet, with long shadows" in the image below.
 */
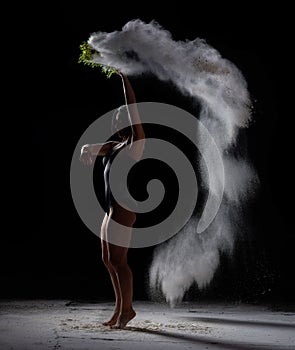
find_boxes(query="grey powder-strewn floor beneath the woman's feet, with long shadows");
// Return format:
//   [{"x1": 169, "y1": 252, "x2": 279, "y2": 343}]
[{"x1": 0, "y1": 300, "x2": 295, "y2": 350}]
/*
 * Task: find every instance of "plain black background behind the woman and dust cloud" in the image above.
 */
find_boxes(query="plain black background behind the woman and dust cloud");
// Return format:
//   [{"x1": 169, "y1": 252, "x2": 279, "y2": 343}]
[{"x1": 0, "y1": 1, "x2": 295, "y2": 303}]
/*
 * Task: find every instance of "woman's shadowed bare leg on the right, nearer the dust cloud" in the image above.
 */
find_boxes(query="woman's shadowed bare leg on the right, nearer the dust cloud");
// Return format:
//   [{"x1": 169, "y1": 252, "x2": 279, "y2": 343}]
[{"x1": 106, "y1": 206, "x2": 136, "y2": 328}]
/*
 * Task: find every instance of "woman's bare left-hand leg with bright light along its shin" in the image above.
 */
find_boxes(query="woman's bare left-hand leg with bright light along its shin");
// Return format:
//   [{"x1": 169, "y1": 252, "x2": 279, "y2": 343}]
[{"x1": 101, "y1": 214, "x2": 121, "y2": 326}]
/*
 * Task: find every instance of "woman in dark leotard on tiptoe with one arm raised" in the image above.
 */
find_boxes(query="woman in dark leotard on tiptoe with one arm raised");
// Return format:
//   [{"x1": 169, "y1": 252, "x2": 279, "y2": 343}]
[{"x1": 80, "y1": 73, "x2": 145, "y2": 328}]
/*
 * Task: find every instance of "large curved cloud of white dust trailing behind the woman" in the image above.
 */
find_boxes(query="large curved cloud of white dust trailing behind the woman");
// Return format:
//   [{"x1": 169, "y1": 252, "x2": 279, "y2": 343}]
[{"x1": 88, "y1": 19, "x2": 258, "y2": 304}]
